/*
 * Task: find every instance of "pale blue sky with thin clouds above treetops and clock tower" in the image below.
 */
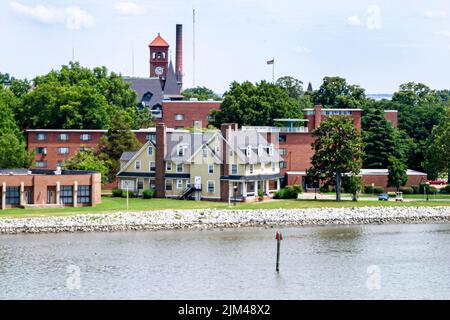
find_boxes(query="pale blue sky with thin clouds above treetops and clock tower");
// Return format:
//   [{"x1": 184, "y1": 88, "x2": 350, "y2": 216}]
[{"x1": 0, "y1": 0, "x2": 450, "y2": 93}]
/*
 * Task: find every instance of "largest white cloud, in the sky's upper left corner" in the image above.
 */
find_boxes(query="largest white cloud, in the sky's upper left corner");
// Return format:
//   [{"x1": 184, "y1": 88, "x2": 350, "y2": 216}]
[{"x1": 10, "y1": 1, "x2": 94, "y2": 30}]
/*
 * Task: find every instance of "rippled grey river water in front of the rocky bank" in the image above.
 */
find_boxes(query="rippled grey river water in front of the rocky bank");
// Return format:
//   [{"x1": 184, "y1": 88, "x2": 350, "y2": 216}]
[{"x1": 0, "y1": 224, "x2": 450, "y2": 299}]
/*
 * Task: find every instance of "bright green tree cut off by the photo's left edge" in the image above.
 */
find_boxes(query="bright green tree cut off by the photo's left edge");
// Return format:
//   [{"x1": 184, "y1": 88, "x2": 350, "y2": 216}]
[{"x1": 0, "y1": 85, "x2": 31, "y2": 168}]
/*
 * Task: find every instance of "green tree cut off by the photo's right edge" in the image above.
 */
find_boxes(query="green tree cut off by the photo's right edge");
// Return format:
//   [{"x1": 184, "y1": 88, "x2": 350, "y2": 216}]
[{"x1": 426, "y1": 105, "x2": 450, "y2": 182}]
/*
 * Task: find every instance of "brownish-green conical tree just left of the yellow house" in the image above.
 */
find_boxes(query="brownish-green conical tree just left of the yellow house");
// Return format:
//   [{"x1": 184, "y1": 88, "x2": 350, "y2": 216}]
[{"x1": 97, "y1": 112, "x2": 141, "y2": 181}]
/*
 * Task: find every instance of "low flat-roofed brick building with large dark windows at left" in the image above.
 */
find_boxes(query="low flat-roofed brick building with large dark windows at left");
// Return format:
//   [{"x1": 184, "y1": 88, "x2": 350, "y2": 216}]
[{"x1": 0, "y1": 169, "x2": 101, "y2": 209}]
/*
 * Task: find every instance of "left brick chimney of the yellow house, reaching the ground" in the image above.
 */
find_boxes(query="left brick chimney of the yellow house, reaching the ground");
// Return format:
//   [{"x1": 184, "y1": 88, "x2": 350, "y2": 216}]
[{"x1": 155, "y1": 123, "x2": 167, "y2": 198}]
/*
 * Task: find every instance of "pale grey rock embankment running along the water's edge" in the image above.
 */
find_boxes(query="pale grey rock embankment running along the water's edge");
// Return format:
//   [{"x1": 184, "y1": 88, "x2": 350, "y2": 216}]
[{"x1": 0, "y1": 207, "x2": 450, "y2": 234}]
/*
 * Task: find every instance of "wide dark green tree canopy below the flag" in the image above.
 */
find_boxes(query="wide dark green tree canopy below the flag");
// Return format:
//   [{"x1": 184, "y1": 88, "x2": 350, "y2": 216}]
[{"x1": 212, "y1": 81, "x2": 302, "y2": 127}]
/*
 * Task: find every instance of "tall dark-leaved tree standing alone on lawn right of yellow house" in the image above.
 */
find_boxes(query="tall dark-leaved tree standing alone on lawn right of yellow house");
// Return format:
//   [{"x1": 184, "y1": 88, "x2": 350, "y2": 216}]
[{"x1": 308, "y1": 116, "x2": 363, "y2": 201}]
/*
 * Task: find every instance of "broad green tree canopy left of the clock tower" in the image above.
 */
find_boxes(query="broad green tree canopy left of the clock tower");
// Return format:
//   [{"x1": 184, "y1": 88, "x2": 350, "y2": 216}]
[{"x1": 15, "y1": 62, "x2": 150, "y2": 129}]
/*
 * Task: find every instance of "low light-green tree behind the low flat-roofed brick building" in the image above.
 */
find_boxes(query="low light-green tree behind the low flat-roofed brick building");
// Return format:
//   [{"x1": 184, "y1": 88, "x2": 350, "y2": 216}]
[{"x1": 61, "y1": 150, "x2": 108, "y2": 183}]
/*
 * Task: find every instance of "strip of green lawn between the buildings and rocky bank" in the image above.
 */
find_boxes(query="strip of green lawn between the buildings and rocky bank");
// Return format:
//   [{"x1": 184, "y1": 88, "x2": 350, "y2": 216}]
[{"x1": 0, "y1": 197, "x2": 450, "y2": 218}]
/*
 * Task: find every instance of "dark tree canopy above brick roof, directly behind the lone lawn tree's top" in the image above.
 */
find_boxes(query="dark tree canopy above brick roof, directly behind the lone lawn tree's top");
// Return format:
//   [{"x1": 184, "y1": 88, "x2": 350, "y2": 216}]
[{"x1": 312, "y1": 77, "x2": 366, "y2": 108}]
